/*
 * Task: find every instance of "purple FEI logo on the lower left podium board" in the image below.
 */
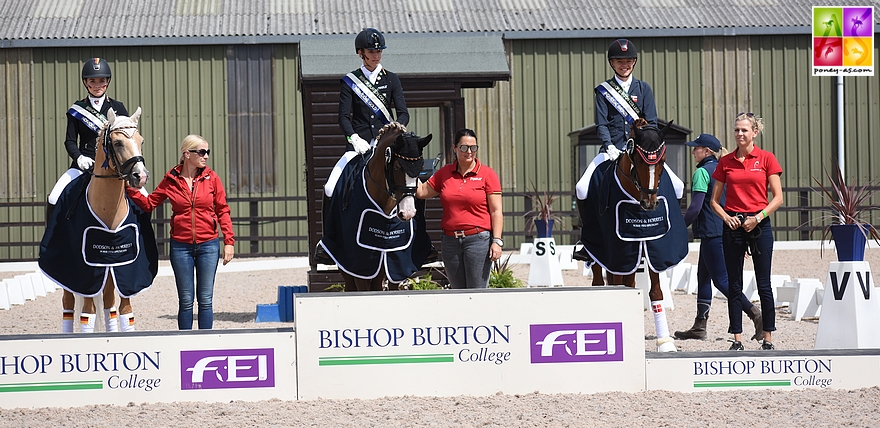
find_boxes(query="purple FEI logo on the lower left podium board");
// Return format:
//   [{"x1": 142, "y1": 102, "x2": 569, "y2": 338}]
[{"x1": 180, "y1": 348, "x2": 275, "y2": 390}]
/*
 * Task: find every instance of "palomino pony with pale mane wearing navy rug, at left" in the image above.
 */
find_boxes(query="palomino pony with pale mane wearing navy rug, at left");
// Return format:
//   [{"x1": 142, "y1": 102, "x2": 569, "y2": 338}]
[{"x1": 39, "y1": 107, "x2": 158, "y2": 332}]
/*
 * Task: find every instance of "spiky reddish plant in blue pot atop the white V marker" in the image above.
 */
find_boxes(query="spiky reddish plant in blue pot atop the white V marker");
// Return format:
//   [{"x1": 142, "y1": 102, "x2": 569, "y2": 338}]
[{"x1": 813, "y1": 164, "x2": 880, "y2": 262}]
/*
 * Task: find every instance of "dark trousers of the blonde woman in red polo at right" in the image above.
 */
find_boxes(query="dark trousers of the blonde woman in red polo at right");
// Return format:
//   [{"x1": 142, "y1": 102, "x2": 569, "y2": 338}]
[{"x1": 722, "y1": 218, "x2": 776, "y2": 334}]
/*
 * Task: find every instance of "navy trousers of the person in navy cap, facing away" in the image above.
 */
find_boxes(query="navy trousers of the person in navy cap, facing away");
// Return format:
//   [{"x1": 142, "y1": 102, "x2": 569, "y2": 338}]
[{"x1": 697, "y1": 236, "x2": 754, "y2": 319}]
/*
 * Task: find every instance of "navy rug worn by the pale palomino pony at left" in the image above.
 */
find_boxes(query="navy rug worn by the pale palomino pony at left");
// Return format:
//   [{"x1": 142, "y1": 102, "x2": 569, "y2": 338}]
[{"x1": 38, "y1": 174, "x2": 159, "y2": 298}]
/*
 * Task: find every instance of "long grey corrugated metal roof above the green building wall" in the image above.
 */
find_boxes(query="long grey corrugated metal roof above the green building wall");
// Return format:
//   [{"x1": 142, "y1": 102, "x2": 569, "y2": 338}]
[{"x1": 0, "y1": 0, "x2": 880, "y2": 47}]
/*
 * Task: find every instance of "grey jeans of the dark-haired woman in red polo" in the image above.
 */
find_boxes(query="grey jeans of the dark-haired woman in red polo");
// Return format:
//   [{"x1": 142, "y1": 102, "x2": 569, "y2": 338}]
[{"x1": 440, "y1": 230, "x2": 492, "y2": 288}]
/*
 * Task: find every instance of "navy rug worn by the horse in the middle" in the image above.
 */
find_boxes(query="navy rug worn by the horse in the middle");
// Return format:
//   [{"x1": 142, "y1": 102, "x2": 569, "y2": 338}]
[{"x1": 318, "y1": 149, "x2": 433, "y2": 283}]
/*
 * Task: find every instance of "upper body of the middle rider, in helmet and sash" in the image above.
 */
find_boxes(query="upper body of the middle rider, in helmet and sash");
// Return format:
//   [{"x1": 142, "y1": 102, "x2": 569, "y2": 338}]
[{"x1": 339, "y1": 28, "x2": 409, "y2": 153}]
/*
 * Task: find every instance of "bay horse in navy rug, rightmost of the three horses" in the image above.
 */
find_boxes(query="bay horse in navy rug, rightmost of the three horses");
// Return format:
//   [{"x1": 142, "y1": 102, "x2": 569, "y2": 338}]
[{"x1": 581, "y1": 119, "x2": 688, "y2": 352}]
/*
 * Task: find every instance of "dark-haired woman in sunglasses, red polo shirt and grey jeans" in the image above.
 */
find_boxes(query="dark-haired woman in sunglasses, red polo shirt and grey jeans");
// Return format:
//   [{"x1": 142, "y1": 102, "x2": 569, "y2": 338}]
[{"x1": 416, "y1": 128, "x2": 504, "y2": 288}]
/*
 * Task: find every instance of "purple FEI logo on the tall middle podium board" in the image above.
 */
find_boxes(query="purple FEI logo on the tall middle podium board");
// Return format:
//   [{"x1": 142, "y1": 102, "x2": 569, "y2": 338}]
[{"x1": 529, "y1": 322, "x2": 623, "y2": 364}]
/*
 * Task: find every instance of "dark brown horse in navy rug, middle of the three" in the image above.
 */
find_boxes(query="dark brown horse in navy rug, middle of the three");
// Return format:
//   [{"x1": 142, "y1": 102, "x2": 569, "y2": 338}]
[{"x1": 318, "y1": 122, "x2": 433, "y2": 291}]
